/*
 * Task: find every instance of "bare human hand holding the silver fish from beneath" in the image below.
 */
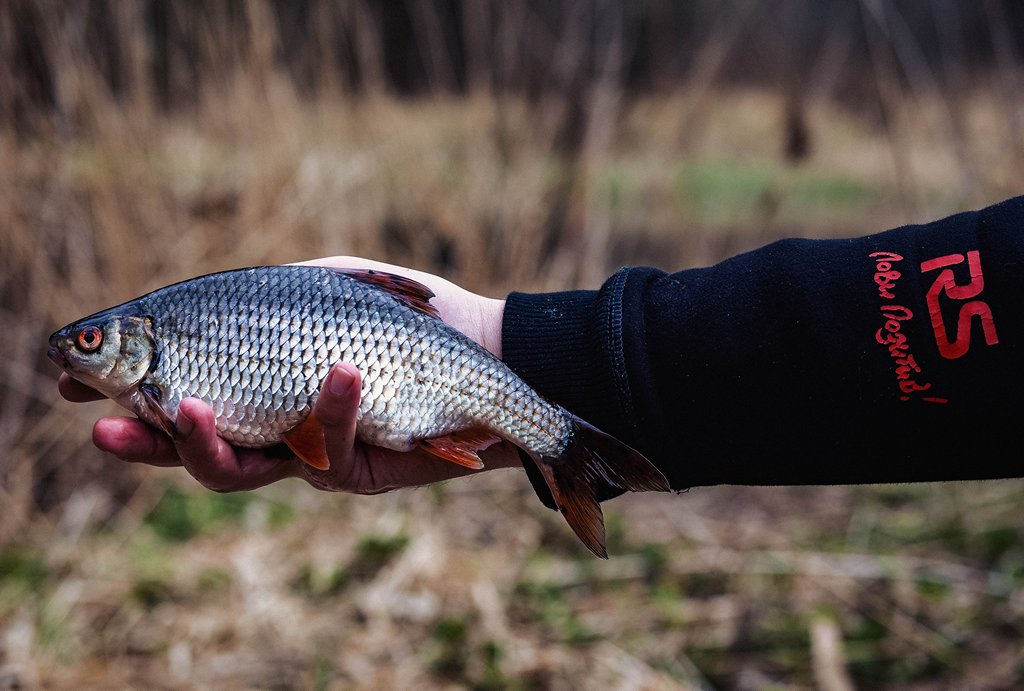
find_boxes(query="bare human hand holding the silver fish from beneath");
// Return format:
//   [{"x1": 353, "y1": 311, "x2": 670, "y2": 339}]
[{"x1": 58, "y1": 257, "x2": 519, "y2": 494}]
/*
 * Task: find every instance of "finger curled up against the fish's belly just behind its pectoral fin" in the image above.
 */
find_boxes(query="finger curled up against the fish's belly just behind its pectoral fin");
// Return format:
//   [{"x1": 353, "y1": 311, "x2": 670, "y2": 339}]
[{"x1": 174, "y1": 398, "x2": 292, "y2": 491}]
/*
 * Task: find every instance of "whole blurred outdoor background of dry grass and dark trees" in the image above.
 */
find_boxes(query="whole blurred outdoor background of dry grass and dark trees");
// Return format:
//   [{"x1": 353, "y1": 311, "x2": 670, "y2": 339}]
[{"x1": 0, "y1": 0, "x2": 1024, "y2": 690}]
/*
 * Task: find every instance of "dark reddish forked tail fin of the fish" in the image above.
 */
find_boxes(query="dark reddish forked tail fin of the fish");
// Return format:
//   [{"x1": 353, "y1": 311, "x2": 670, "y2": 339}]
[{"x1": 532, "y1": 416, "x2": 670, "y2": 559}]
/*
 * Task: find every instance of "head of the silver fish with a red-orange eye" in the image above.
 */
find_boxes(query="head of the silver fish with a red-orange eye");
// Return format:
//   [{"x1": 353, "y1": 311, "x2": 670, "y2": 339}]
[{"x1": 47, "y1": 312, "x2": 156, "y2": 398}]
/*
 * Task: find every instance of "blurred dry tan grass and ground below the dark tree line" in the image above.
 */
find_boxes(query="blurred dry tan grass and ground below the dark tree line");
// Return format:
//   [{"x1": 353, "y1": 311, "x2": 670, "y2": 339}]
[{"x1": 0, "y1": 16, "x2": 1024, "y2": 689}]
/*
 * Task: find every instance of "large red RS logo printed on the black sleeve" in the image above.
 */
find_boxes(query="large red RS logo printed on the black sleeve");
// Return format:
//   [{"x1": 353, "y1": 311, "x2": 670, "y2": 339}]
[{"x1": 921, "y1": 250, "x2": 999, "y2": 359}]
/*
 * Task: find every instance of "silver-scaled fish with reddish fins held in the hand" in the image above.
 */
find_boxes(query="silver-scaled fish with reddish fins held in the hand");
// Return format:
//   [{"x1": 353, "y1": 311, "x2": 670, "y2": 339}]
[{"x1": 47, "y1": 265, "x2": 669, "y2": 558}]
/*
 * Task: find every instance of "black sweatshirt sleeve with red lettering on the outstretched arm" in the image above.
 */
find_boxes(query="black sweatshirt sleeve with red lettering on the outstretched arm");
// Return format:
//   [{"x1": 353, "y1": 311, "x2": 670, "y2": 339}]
[{"x1": 502, "y1": 197, "x2": 1024, "y2": 506}]
